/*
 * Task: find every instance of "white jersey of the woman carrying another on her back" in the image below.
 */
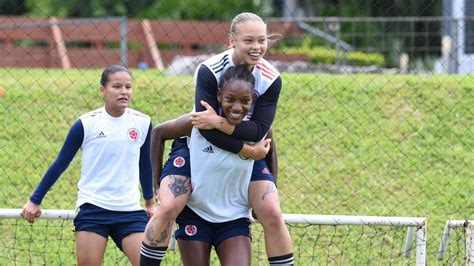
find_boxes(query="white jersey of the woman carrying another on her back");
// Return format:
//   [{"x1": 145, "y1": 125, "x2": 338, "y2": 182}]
[{"x1": 187, "y1": 128, "x2": 254, "y2": 223}]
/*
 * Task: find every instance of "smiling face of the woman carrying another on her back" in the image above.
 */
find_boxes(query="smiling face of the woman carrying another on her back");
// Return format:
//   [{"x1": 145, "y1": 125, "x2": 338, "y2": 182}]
[{"x1": 217, "y1": 79, "x2": 253, "y2": 125}]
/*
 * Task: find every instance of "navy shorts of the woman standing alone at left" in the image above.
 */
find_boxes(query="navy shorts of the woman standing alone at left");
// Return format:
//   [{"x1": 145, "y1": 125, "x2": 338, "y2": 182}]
[{"x1": 74, "y1": 203, "x2": 148, "y2": 250}]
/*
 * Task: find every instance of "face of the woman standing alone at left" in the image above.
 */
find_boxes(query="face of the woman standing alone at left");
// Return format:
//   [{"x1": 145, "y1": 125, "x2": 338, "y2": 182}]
[{"x1": 100, "y1": 71, "x2": 132, "y2": 117}]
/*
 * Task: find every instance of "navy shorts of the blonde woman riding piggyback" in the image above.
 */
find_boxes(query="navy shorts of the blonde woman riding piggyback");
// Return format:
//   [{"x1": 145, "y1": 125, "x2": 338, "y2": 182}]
[{"x1": 160, "y1": 138, "x2": 275, "y2": 183}]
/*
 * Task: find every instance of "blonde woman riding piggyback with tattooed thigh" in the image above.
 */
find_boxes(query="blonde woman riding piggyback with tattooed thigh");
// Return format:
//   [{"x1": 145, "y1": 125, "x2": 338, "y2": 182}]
[{"x1": 144, "y1": 13, "x2": 293, "y2": 265}]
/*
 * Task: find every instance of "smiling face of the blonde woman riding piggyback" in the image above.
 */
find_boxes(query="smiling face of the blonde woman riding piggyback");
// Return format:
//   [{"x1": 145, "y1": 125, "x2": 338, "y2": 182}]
[{"x1": 230, "y1": 20, "x2": 268, "y2": 66}]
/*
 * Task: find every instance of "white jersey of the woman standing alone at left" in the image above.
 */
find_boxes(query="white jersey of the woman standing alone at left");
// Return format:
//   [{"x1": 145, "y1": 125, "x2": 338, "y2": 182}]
[{"x1": 76, "y1": 107, "x2": 150, "y2": 211}]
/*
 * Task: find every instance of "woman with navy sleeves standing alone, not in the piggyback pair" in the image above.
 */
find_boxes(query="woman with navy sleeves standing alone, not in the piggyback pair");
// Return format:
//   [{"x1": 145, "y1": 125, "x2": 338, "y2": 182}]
[{"x1": 22, "y1": 65, "x2": 153, "y2": 265}]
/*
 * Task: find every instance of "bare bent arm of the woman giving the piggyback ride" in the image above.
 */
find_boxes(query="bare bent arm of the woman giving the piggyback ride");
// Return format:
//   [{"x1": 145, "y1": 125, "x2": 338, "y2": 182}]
[{"x1": 151, "y1": 114, "x2": 192, "y2": 195}]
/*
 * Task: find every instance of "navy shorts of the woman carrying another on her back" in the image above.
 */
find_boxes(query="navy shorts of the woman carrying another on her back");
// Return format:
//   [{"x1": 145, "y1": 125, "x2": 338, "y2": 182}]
[{"x1": 175, "y1": 206, "x2": 252, "y2": 249}]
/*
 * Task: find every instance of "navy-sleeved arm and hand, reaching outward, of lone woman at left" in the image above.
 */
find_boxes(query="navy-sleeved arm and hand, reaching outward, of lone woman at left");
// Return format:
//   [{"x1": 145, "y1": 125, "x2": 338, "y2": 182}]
[{"x1": 22, "y1": 120, "x2": 84, "y2": 223}]
